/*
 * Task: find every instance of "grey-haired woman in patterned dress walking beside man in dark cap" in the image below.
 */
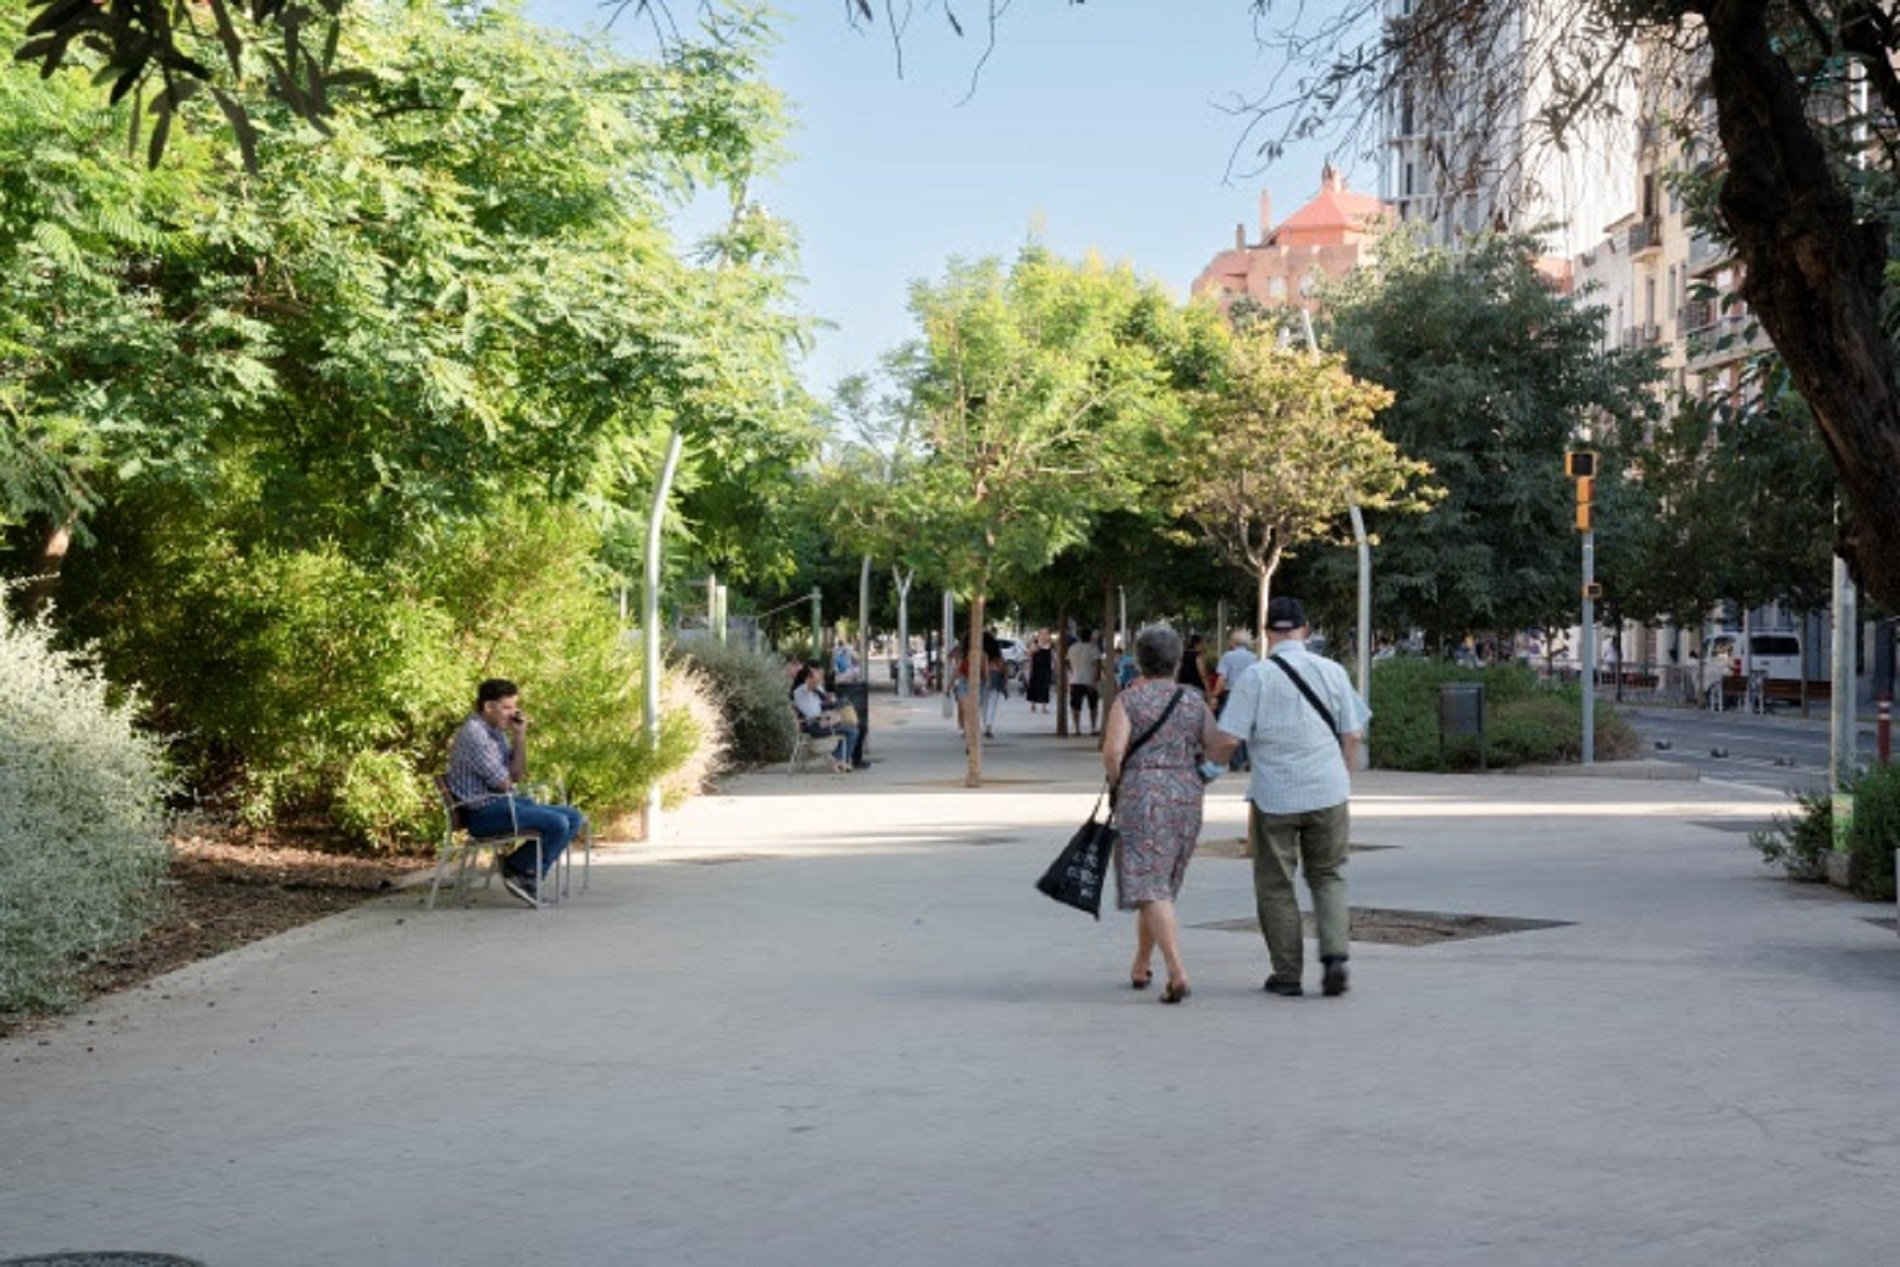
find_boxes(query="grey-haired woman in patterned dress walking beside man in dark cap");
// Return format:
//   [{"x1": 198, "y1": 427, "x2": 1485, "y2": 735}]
[{"x1": 1102, "y1": 625, "x2": 1235, "y2": 1003}]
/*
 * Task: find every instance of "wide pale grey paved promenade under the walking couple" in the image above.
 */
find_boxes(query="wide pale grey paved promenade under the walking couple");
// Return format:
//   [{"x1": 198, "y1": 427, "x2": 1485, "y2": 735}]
[{"x1": 0, "y1": 695, "x2": 1900, "y2": 1267}]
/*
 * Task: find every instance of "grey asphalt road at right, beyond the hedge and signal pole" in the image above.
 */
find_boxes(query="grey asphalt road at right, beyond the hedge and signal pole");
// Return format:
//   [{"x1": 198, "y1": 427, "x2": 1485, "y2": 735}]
[{"x1": 1623, "y1": 707, "x2": 1873, "y2": 792}]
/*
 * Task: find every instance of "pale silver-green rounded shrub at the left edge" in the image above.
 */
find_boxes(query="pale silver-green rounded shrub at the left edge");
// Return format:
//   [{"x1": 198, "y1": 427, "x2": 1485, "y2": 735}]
[{"x1": 0, "y1": 608, "x2": 171, "y2": 1012}]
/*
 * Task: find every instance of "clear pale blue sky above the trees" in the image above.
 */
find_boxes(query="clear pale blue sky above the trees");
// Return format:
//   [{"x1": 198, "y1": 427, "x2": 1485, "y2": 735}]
[{"x1": 528, "y1": 0, "x2": 1345, "y2": 393}]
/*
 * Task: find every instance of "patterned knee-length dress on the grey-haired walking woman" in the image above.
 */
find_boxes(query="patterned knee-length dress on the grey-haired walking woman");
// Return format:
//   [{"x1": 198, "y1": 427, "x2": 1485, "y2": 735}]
[{"x1": 1115, "y1": 678, "x2": 1207, "y2": 910}]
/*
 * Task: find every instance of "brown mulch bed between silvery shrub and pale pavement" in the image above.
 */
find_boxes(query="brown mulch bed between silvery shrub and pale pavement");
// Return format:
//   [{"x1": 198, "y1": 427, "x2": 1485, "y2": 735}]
[{"x1": 0, "y1": 828, "x2": 429, "y2": 1035}]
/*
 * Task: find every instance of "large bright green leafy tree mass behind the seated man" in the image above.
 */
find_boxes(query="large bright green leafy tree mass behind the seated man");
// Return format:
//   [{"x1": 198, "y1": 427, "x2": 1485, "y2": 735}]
[{"x1": 0, "y1": 6, "x2": 813, "y2": 843}]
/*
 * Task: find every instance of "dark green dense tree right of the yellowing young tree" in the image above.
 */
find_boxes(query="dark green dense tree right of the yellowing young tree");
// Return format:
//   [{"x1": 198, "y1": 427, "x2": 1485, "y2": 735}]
[{"x1": 1332, "y1": 234, "x2": 1655, "y2": 653}]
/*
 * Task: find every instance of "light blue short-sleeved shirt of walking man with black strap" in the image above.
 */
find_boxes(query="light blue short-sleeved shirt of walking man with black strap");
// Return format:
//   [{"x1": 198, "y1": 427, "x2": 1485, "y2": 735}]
[{"x1": 1220, "y1": 638, "x2": 1372, "y2": 813}]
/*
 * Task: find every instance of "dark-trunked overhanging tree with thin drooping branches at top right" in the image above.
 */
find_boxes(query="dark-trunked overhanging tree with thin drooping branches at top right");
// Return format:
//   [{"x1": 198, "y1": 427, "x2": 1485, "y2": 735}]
[{"x1": 1252, "y1": 0, "x2": 1900, "y2": 606}]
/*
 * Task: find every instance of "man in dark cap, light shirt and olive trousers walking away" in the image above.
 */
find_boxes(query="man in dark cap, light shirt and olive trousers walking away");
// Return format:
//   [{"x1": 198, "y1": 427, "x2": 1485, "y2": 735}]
[{"x1": 1220, "y1": 598, "x2": 1372, "y2": 995}]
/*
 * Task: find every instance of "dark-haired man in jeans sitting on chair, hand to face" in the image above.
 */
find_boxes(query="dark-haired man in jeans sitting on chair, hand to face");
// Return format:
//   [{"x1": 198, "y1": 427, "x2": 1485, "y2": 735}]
[{"x1": 448, "y1": 678, "x2": 587, "y2": 906}]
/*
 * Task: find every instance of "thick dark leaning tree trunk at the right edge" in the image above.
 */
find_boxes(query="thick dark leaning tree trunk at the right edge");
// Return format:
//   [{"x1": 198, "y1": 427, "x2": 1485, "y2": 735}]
[{"x1": 1689, "y1": 0, "x2": 1900, "y2": 608}]
